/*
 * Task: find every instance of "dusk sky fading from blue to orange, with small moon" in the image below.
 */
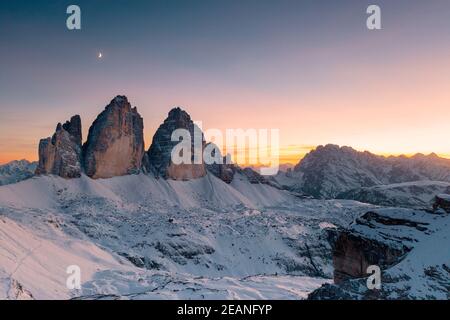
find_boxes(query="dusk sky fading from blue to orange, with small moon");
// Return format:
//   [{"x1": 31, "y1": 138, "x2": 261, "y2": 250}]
[{"x1": 0, "y1": 0, "x2": 450, "y2": 163}]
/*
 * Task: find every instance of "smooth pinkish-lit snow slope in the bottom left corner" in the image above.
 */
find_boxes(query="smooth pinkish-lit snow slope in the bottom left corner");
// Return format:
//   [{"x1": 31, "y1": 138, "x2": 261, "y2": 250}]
[{"x1": 0, "y1": 215, "x2": 126, "y2": 299}]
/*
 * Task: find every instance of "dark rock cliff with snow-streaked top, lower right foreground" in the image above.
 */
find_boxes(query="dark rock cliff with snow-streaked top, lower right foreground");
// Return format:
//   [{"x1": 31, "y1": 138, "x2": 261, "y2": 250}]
[{"x1": 333, "y1": 208, "x2": 431, "y2": 283}]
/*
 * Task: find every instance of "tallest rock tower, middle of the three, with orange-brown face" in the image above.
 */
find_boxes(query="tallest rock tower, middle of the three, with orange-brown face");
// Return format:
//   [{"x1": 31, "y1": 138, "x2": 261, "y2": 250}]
[{"x1": 83, "y1": 96, "x2": 144, "y2": 179}]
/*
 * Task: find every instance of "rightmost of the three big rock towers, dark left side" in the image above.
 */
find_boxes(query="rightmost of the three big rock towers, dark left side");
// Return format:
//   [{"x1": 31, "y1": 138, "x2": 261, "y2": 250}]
[{"x1": 147, "y1": 108, "x2": 206, "y2": 180}]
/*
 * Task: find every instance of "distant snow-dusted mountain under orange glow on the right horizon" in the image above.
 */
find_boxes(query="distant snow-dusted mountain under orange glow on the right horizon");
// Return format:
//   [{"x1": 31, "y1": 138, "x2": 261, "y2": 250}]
[{"x1": 276, "y1": 145, "x2": 450, "y2": 199}]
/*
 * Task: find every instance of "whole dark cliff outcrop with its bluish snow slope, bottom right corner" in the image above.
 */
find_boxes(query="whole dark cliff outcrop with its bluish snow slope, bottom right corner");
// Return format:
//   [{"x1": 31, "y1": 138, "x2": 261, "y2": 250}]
[{"x1": 309, "y1": 199, "x2": 450, "y2": 300}]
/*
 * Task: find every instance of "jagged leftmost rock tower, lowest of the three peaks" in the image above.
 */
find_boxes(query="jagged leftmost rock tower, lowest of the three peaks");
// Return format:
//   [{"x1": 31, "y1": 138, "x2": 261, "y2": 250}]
[{"x1": 36, "y1": 115, "x2": 82, "y2": 179}]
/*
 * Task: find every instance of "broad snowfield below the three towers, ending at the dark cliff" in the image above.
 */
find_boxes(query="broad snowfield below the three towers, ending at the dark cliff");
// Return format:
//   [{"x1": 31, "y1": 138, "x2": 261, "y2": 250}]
[{"x1": 0, "y1": 174, "x2": 370, "y2": 299}]
